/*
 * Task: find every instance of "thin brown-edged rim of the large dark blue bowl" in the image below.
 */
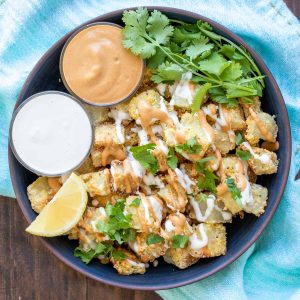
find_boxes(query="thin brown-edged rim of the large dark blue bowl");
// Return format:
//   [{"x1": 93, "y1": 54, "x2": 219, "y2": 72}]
[{"x1": 8, "y1": 6, "x2": 291, "y2": 290}]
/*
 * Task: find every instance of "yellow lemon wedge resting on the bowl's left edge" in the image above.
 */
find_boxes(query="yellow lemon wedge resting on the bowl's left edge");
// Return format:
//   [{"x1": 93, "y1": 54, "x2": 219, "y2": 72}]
[{"x1": 26, "y1": 173, "x2": 88, "y2": 237}]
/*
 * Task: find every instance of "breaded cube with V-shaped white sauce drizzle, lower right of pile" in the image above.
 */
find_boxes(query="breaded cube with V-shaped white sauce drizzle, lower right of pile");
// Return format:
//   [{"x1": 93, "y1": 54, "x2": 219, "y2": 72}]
[{"x1": 189, "y1": 193, "x2": 232, "y2": 223}]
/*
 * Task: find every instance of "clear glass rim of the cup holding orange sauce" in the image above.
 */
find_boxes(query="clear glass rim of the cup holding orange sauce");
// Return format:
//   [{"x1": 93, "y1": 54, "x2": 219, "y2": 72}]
[{"x1": 58, "y1": 21, "x2": 146, "y2": 107}]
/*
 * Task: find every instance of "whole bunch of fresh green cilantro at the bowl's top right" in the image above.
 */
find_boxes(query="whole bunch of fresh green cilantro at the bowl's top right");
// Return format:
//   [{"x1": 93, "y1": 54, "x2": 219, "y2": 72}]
[{"x1": 123, "y1": 8, "x2": 264, "y2": 112}]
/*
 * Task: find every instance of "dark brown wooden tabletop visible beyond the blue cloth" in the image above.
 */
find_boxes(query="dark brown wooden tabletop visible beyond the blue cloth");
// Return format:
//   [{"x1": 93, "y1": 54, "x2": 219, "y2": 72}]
[{"x1": 0, "y1": 0, "x2": 300, "y2": 300}]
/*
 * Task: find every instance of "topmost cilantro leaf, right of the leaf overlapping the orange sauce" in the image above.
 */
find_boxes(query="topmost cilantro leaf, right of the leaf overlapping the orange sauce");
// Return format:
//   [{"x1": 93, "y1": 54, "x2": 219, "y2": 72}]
[{"x1": 147, "y1": 10, "x2": 174, "y2": 44}]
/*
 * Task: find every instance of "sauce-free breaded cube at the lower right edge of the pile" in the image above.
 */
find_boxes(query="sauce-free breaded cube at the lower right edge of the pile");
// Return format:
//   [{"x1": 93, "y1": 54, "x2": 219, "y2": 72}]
[{"x1": 244, "y1": 183, "x2": 268, "y2": 217}]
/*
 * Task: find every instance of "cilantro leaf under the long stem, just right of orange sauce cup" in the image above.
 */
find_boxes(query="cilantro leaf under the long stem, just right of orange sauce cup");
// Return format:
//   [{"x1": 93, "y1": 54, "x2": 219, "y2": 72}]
[{"x1": 151, "y1": 61, "x2": 184, "y2": 83}]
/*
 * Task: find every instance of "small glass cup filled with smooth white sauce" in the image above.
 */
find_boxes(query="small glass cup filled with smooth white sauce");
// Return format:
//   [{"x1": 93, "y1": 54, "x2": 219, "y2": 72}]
[{"x1": 10, "y1": 91, "x2": 93, "y2": 176}]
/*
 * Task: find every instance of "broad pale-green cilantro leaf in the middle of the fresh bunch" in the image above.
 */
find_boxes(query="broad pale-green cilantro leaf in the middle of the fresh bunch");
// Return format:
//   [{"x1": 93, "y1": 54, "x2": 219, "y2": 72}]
[{"x1": 199, "y1": 52, "x2": 230, "y2": 76}]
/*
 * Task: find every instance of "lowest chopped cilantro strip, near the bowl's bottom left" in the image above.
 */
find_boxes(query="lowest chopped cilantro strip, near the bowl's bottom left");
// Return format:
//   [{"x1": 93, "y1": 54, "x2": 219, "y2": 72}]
[{"x1": 74, "y1": 243, "x2": 126, "y2": 264}]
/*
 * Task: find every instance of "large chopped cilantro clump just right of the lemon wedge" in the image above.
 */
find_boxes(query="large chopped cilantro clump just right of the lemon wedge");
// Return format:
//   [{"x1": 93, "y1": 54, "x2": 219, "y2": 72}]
[{"x1": 96, "y1": 199, "x2": 135, "y2": 244}]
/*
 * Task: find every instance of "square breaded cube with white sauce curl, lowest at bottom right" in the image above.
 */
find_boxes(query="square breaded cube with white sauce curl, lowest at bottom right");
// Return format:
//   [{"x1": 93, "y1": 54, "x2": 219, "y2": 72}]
[{"x1": 189, "y1": 223, "x2": 226, "y2": 258}]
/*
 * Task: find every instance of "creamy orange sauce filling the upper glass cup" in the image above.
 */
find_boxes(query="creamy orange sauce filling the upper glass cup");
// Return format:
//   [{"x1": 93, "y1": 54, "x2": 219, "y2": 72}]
[{"x1": 61, "y1": 24, "x2": 144, "y2": 104}]
